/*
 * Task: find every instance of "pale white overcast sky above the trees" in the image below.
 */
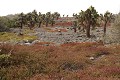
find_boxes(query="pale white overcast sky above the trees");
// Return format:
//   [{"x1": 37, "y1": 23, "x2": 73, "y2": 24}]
[{"x1": 0, "y1": 0, "x2": 120, "y2": 16}]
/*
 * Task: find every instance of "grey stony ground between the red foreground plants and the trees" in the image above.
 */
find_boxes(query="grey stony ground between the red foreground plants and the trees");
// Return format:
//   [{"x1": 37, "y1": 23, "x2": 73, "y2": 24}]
[{"x1": 35, "y1": 27, "x2": 103, "y2": 44}]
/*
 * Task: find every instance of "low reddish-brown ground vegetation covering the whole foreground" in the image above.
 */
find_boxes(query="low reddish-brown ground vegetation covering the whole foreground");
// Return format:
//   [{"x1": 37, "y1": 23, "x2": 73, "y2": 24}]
[{"x1": 0, "y1": 42, "x2": 120, "y2": 80}]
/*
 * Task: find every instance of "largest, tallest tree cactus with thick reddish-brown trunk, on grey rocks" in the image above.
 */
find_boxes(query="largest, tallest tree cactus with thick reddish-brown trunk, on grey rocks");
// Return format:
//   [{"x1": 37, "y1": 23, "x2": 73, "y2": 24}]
[{"x1": 76, "y1": 6, "x2": 99, "y2": 38}]
